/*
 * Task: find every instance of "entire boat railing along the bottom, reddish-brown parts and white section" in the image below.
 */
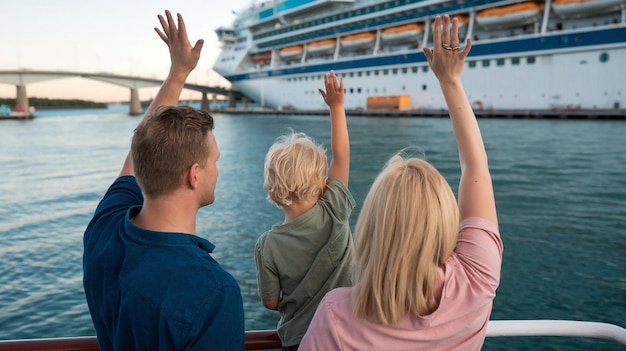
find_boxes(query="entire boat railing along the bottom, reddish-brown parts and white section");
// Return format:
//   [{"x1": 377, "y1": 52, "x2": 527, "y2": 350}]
[{"x1": 0, "y1": 320, "x2": 626, "y2": 351}]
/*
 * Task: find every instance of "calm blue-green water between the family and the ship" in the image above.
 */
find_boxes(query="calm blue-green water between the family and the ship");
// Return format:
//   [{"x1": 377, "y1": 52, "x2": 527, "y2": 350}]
[{"x1": 0, "y1": 107, "x2": 626, "y2": 350}]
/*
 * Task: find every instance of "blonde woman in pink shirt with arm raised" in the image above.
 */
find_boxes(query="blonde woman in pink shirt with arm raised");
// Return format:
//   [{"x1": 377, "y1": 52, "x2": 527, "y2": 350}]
[{"x1": 300, "y1": 15, "x2": 502, "y2": 350}]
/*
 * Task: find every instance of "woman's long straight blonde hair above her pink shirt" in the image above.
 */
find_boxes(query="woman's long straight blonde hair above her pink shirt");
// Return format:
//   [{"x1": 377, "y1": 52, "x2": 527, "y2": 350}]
[{"x1": 353, "y1": 155, "x2": 459, "y2": 325}]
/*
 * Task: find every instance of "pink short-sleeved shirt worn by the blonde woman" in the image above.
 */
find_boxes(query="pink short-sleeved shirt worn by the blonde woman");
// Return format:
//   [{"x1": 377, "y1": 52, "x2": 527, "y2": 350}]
[{"x1": 299, "y1": 217, "x2": 502, "y2": 351}]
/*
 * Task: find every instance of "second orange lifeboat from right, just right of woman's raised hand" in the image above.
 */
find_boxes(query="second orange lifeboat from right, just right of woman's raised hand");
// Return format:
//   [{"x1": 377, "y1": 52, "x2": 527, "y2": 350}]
[{"x1": 476, "y1": 2, "x2": 544, "y2": 28}]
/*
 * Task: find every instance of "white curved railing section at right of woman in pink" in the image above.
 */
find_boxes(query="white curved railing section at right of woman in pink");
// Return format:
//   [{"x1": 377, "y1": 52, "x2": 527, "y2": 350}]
[{"x1": 487, "y1": 319, "x2": 626, "y2": 345}]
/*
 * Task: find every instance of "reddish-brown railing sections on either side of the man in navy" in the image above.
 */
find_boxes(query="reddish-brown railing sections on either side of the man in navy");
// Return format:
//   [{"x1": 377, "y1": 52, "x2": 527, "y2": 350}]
[{"x1": 0, "y1": 330, "x2": 282, "y2": 351}]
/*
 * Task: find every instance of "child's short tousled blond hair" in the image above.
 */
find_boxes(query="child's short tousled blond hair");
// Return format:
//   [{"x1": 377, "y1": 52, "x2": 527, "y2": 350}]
[{"x1": 263, "y1": 131, "x2": 328, "y2": 208}]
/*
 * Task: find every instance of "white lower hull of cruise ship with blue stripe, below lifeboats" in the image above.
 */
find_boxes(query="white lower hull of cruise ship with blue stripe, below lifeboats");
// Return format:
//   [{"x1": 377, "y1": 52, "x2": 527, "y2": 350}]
[{"x1": 218, "y1": 0, "x2": 626, "y2": 110}]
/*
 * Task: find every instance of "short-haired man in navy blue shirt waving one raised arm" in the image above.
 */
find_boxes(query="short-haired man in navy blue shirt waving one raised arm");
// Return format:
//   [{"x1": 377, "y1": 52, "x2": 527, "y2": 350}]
[{"x1": 83, "y1": 11, "x2": 245, "y2": 350}]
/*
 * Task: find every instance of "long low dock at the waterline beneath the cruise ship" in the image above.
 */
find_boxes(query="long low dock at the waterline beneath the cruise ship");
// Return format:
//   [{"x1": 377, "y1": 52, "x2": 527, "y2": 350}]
[{"x1": 212, "y1": 107, "x2": 626, "y2": 120}]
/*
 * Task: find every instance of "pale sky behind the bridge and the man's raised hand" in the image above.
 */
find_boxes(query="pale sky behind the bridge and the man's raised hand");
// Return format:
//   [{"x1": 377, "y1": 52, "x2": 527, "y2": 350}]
[{"x1": 0, "y1": 0, "x2": 252, "y2": 102}]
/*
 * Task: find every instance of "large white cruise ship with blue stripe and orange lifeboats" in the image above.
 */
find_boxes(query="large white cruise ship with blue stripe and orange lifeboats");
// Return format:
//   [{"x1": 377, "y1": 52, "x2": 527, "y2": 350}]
[{"x1": 213, "y1": 0, "x2": 626, "y2": 111}]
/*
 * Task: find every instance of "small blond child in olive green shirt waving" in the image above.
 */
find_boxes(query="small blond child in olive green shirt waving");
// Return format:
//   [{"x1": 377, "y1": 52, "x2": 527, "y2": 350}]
[{"x1": 255, "y1": 71, "x2": 355, "y2": 350}]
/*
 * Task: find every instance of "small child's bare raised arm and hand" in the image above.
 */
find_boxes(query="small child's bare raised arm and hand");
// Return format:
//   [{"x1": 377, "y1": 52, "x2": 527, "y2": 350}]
[{"x1": 319, "y1": 71, "x2": 350, "y2": 186}]
